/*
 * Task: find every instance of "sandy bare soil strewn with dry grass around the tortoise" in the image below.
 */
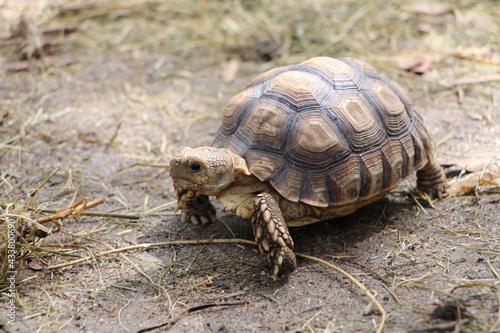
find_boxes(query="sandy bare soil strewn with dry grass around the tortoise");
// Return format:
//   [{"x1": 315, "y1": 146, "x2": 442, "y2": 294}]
[{"x1": 0, "y1": 0, "x2": 500, "y2": 332}]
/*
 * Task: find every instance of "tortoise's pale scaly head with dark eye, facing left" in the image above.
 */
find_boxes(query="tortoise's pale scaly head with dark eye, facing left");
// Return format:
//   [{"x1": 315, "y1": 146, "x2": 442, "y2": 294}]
[{"x1": 170, "y1": 147, "x2": 250, "y2": 195}]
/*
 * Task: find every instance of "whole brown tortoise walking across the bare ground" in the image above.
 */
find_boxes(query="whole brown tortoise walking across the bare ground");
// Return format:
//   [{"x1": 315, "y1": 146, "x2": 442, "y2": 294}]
[{"x1": 170, "y1": 57, "x2": 446, "y2": 279}]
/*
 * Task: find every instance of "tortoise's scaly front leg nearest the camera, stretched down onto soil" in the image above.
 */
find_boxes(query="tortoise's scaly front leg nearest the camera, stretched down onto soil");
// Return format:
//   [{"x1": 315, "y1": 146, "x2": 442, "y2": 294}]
[{"x1": 252, "y1": 193, "x2": 296, "y2": 280}]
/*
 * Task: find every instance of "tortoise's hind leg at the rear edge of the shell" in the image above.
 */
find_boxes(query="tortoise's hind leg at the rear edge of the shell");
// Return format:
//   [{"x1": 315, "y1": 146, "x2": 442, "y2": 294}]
[{"x1": 417, "y1": 157, "x2": 447, "y2": 199}]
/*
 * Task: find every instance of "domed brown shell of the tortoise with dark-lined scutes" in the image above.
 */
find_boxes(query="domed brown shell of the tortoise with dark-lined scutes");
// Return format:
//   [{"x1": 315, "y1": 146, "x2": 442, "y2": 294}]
[{"x1": 213, "y1": 57, "x2": 432, "y2": 207}]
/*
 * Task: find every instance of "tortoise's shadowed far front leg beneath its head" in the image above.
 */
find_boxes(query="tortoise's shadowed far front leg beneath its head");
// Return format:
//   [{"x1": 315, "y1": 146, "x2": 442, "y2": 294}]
[{"x1": 175, "y1": 186, "x2": 217, "y2": 224}]
